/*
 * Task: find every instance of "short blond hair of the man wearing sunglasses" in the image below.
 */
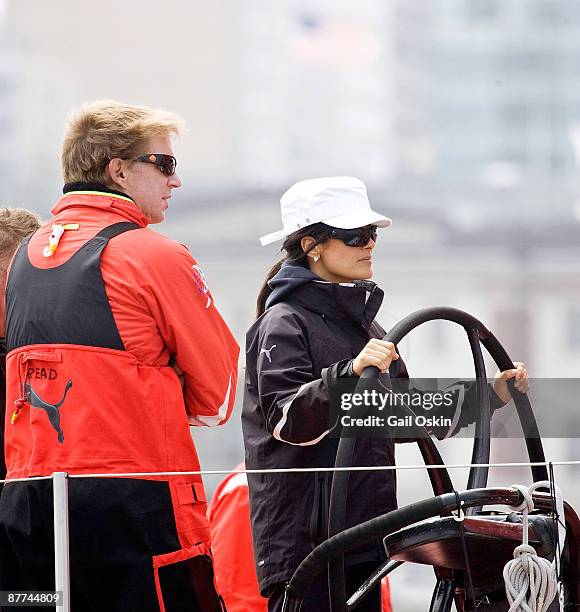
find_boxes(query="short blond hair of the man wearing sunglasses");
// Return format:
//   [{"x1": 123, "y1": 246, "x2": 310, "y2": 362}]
[{"x1": 61, "y1": 100, "x2": 183, "y2": 184}]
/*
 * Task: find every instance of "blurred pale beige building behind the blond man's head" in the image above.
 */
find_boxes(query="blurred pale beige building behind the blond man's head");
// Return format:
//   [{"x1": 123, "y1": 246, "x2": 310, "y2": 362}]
[{"x1": 3, "y1": 0, "x2": 238, "y2": 203}]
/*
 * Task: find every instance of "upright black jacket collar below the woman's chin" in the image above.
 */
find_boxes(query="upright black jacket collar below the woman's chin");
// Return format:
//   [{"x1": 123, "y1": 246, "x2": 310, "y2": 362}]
[{"x1": 288, "y1": 280, "x2": 384, "y2": 330}]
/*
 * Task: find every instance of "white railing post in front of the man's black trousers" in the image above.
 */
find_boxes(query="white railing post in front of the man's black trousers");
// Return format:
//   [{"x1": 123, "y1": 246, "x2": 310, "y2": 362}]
[{"x1": 52, "y1": 472, "x2": 70, "y2": 612}]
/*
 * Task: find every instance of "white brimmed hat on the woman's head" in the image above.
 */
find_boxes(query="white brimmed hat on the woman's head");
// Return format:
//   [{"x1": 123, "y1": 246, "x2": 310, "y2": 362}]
[{"x1": 260, "y1": 176, "x2": 393, "y2": 246}]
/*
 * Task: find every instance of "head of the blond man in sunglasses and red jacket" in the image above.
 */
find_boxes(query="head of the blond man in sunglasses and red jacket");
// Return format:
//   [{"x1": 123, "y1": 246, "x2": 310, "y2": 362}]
[{"x1": 61, "y1": 100, "x2": 183, "y2": 223}]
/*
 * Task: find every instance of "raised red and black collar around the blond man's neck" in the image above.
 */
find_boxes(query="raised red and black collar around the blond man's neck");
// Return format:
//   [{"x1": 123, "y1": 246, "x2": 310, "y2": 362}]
[{"x1": 51, "y1": 183, "x2": 148, "y2": 227}]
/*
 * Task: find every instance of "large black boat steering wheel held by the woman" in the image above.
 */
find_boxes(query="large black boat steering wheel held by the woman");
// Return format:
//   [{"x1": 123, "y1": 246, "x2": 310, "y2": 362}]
[{"x1": 284, "y1": 307, "x2": 548, "y2": 612}]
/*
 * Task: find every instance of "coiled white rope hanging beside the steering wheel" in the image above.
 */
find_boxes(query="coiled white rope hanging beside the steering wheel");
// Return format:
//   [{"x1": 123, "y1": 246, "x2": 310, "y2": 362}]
[{"x1": 503, "y1": 480, "x2": 566, "y2": 612}]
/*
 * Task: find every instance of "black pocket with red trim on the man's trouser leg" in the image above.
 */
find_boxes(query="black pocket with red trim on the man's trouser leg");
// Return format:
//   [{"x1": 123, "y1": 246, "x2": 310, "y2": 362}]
[{"x1": 153, "y1": 544, "x2": 226, "y2": 612}]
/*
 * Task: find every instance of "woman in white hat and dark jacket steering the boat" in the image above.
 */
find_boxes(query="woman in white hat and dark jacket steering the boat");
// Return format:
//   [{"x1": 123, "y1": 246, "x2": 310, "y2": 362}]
[{"x1": 242, "y1": 177, "x2": 527, "y2": 612}]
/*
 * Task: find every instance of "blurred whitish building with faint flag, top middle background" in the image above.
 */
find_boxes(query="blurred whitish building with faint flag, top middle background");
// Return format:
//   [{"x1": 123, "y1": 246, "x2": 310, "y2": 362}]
[{"x1": 239, "y1": 0, "x2": 395, "y2": 188}]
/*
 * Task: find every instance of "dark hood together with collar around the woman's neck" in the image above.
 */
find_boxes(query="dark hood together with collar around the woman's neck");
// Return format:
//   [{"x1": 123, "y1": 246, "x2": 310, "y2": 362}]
[{"x1": 266, "y1": 261, "x2": 384, "y2": 329}]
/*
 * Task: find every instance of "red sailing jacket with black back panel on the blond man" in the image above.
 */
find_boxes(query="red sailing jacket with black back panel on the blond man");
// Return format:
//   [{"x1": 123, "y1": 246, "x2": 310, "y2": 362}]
[{"x1": 5, "y1": 192, "x2": 239, "y2": 546}]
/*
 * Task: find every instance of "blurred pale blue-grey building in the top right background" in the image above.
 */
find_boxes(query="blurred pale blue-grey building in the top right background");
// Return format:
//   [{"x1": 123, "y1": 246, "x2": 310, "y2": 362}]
[{"x1": 396, "y1": 0, "x2": 580, "y2": 194}]
